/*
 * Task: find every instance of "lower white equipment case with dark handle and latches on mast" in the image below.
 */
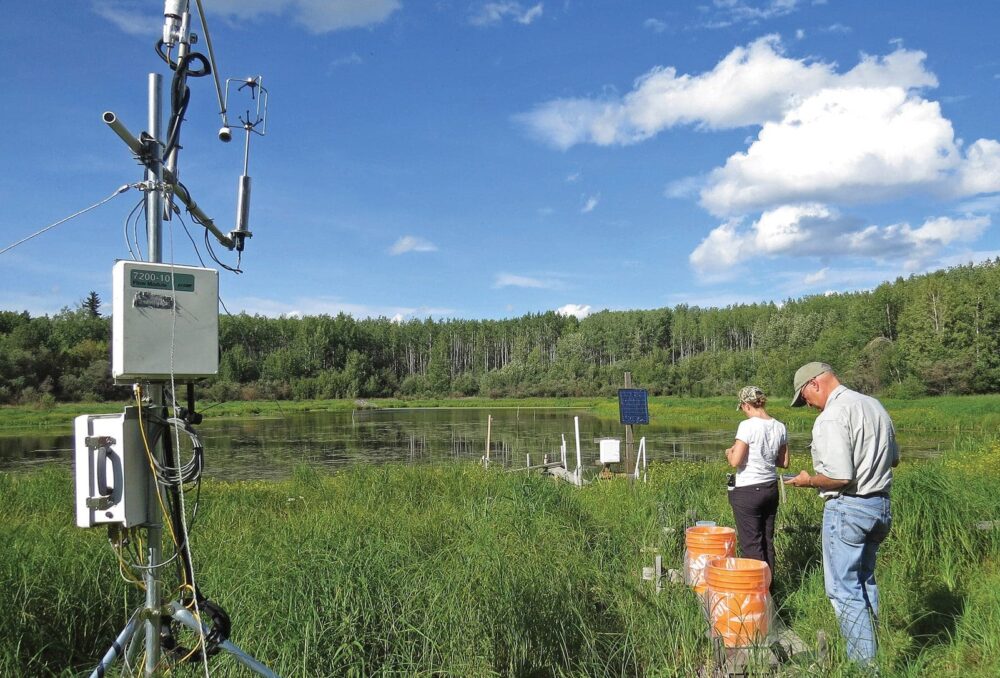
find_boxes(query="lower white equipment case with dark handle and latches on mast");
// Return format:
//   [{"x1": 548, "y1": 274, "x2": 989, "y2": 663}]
[{"x1": 73, "y1": 407, "x2": 151, "y2": 527}]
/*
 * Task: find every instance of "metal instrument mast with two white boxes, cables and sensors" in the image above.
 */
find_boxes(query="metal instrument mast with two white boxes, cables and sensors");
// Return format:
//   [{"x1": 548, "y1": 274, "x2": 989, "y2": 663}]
[{"x1": 74, "y1": 0, "x2": 275, "y2": 678}]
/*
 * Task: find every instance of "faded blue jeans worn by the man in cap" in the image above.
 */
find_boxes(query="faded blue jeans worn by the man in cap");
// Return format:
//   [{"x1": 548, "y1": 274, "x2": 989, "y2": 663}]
[{"x1": 823, "y1": 497, "x2": 892, "y2": 663}]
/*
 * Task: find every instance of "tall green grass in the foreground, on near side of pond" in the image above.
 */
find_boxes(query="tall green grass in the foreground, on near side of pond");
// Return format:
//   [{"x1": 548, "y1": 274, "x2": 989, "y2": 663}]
[{"x1": 0, "y1": 438, "x2": 1000, "y2": 678}]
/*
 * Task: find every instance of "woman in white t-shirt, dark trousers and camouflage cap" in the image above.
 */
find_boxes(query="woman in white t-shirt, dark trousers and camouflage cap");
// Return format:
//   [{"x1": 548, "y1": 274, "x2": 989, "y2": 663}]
[{"x1": 726, "y1": 386, "x2": 788, "y2": 580}]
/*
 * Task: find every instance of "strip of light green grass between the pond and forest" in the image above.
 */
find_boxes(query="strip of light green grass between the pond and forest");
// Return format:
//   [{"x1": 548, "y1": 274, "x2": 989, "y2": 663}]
[{"x1": 0, "y1": 394, "x2": 1000, "y2": 435}]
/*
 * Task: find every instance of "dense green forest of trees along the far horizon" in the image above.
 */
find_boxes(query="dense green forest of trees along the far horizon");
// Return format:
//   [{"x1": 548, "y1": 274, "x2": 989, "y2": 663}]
[{"x1": 0, "y1": 258, "x2": 1000, "y2": 404}]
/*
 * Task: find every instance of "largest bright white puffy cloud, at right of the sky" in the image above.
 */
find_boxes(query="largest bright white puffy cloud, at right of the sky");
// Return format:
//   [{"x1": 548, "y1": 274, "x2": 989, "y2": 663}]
[{"x1": 701, "y1": 87, "x2": 961, "y2": 215}]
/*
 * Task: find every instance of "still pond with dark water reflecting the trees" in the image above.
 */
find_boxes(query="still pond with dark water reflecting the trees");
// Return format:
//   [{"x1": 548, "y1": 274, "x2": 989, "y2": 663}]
[{"x1": 0, "y1": 408, "x2": 951, "y2": 480}]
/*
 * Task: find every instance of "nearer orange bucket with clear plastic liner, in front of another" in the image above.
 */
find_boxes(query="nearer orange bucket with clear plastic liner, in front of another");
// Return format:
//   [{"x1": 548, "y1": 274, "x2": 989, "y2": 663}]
[{"x1": 705, "y1": 558, "x2": 771, "y2": 647}]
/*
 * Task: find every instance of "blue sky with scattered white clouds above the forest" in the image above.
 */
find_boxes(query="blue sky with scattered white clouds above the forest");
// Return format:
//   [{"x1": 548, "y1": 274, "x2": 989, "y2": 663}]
[{"x1": 0, "y1": 0, "x2": 1000, "y2": 319}]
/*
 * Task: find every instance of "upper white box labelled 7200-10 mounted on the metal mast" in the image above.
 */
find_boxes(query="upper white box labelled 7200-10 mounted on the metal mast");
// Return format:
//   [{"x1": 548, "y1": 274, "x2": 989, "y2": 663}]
[{"x1": 111, "y1": 261, "x2": 219, "y2": 382}]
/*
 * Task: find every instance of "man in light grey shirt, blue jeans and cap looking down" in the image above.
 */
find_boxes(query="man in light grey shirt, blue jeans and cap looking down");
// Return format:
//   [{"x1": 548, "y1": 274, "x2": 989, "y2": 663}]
[{"x1": 785, "y1": 362, "x2": 899, "y2": 664}]
